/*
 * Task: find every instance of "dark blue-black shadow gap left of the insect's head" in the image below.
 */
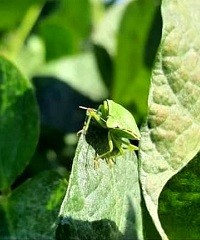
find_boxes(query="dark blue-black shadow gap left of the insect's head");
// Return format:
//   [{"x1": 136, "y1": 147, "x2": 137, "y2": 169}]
[{"x1": 33, "y1": 77, "x2": 97, "y2": 134}]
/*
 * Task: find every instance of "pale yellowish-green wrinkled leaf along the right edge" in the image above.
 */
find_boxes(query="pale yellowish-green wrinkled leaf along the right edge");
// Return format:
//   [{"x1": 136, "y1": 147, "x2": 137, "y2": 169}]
[{"x1": 140, "y1": 0, "x2": 200, "y2": 239}]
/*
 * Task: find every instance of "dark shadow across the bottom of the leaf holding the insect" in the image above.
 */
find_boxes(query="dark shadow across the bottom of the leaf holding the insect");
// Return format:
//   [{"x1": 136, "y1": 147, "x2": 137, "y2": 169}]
[{"x1": 56, "y1": 199, "x2": 139, "y2": 240}]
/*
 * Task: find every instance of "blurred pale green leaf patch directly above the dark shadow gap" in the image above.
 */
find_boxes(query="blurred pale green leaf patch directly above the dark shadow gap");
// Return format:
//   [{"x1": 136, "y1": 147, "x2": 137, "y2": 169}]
[{"x1": 39, "y1": 52, "x2": 108, "y2": 101}]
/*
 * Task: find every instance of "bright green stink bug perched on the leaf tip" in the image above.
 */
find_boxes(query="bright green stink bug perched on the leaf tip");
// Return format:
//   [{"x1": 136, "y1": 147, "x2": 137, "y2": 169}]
[{"x1": 80, "y1": 100, "x2": 141, "y2": 165}]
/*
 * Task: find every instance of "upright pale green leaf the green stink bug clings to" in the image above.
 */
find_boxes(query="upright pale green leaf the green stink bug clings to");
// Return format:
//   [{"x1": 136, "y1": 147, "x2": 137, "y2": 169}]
[{"x1": 56, "y1": 128, "x2": 143, "y2": 240}]
